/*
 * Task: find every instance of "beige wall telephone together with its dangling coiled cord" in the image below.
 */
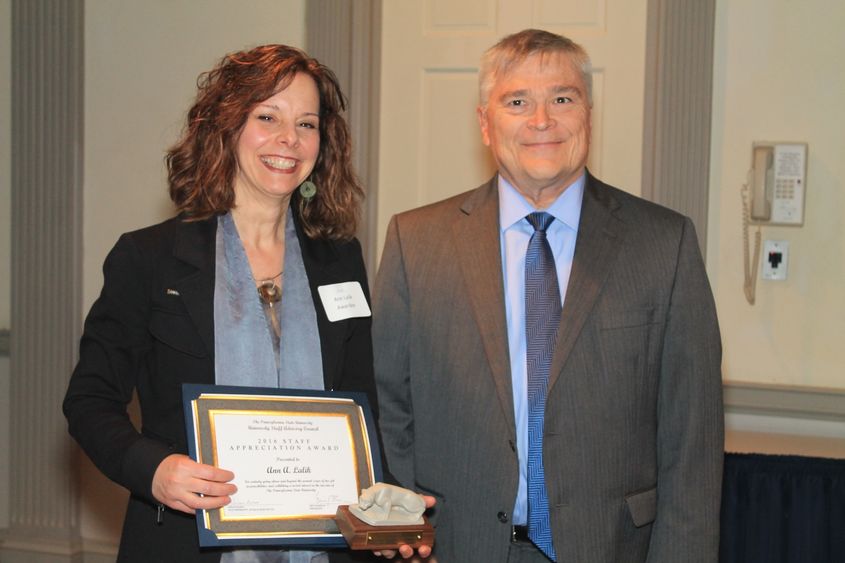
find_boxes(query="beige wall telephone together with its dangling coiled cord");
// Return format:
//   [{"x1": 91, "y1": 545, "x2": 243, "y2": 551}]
[{"x1": 741, "y1": 142, "x2": 807, "y2": 305}]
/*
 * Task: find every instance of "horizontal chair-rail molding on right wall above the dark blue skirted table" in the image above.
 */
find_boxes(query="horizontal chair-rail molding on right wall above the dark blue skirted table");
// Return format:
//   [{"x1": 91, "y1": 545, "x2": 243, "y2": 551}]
[{"x1": 723, "y1": 381, "x2": 845, "y2": 423}]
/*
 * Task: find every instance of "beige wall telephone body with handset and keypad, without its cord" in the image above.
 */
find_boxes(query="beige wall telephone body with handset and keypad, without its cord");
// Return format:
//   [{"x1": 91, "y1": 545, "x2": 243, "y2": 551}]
[{"x1": 750, "y1": 142, "x2": 807, "y2": 226}]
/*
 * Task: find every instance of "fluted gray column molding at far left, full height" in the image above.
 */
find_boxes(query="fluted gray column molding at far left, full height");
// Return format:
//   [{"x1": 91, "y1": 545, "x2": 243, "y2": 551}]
[{"x1": 0, "y1": 0, "x2": 85, "y2": 562}]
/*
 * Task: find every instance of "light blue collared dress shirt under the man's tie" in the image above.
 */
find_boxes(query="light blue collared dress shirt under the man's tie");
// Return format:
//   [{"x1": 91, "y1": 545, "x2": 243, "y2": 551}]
[{"x1": 499, "y1": 174, "x2": 586, "y2": 525}]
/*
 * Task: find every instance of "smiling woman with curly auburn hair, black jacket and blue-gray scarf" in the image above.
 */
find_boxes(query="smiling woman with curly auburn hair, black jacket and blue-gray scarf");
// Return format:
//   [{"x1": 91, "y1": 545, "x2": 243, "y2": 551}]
[{"x1": 64, "y1": 45, "x2": 418, "y2": 563}]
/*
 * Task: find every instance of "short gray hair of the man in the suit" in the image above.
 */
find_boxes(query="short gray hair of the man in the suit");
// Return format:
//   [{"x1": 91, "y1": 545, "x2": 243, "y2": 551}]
[{"x1": 478, "y1": 29, "x2": 593, "y2": 106}]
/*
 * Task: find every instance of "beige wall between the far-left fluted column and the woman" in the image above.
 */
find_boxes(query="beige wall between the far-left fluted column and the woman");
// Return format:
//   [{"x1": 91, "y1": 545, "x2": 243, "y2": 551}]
[{"x1": 79, "y1": 0, "x2": 305, "y2": 552}]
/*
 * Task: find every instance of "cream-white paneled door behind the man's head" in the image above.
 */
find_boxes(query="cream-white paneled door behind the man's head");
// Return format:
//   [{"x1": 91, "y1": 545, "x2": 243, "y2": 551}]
[{"x1": 378, "y1": 0, "x2": 647, "y2": 252}]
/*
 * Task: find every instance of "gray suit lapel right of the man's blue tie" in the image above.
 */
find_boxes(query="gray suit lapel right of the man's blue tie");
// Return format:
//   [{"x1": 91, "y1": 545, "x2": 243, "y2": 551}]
[{"x1": 549, "y1": 175, "x2": 625, "y2": 389}]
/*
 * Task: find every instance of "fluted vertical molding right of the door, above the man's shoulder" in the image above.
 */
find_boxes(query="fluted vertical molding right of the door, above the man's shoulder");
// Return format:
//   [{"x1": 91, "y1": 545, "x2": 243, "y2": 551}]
[{"x1": 642, "y1": 0, "x2": 716, "y2": 256}]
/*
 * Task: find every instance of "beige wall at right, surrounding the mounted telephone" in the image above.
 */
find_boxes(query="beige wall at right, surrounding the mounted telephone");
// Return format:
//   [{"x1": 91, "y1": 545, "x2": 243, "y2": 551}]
[{"x1": 707, "y1": 0, "x2": 845, "y2": 392}]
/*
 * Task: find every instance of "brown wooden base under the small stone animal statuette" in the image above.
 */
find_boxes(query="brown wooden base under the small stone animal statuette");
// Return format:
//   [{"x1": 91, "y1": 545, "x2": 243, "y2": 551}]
[{"x1": 335, "y1": 504, "x2": 434, "y2": 549}]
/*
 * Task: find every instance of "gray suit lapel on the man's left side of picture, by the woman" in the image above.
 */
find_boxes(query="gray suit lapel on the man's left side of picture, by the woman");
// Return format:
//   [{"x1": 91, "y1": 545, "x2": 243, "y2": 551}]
[{"x1": 452, "y1": 181, "x2": 515, "y2": 440}]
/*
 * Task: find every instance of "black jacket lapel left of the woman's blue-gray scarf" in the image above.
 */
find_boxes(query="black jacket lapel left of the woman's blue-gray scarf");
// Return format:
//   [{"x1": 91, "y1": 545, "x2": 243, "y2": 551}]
[{"x1": 170, "y1": 217, "x2": 217, "y2": 358}]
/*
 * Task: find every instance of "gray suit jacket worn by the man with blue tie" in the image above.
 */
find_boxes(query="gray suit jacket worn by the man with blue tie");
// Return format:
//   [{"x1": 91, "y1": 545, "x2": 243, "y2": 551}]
[{"x1": 373, "y1": 176, "x2": 723, "y2": 563}]
